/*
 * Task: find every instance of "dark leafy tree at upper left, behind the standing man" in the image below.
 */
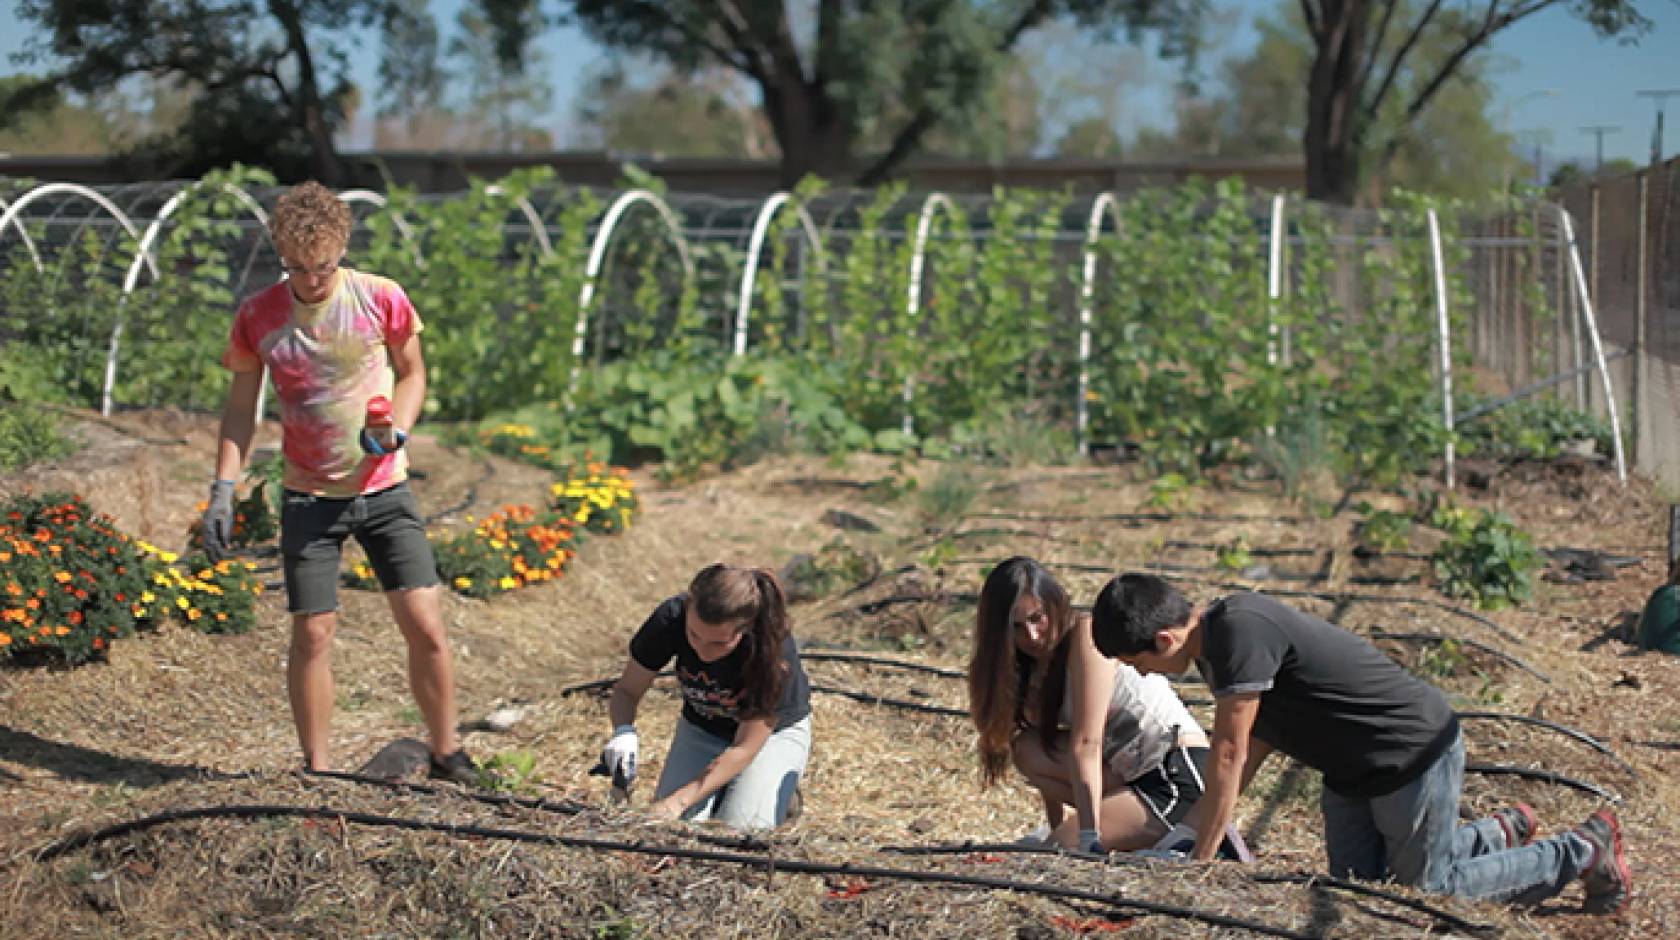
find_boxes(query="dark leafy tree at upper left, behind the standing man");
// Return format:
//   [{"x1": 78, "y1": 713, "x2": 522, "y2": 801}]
[{"x1": 18, "y1": 0, "x2": 435, "y2": 185}]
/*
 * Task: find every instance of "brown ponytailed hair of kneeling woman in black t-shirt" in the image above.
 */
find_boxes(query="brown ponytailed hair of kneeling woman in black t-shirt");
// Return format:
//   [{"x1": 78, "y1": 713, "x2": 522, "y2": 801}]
[{"x1": 689, "y1": 564, "x2": 788, "y2": 718}]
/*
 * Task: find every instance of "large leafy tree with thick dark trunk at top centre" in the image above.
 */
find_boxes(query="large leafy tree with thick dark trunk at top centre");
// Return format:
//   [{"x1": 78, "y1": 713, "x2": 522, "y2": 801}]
[{"x1": 503, "y1": 0, "x2": 1205, "y2": 186}]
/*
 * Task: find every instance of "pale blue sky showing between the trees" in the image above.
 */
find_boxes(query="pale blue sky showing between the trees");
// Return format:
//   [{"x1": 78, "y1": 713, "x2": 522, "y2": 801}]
[{"x1": 0, "y1": 0, "x2": 1680, "y2": 166}]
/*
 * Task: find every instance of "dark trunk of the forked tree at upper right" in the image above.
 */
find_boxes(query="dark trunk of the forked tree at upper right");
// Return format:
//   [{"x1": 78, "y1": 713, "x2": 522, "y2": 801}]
[{"x1": 1302, "y1": 0, "x2": 1369, "y2": 205}]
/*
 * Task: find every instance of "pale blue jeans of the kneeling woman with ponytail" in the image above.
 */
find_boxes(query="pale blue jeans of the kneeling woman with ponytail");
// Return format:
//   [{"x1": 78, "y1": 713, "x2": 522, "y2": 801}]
[{"x1": 654, "y1": 715, "x2": 811, "y2": 829}]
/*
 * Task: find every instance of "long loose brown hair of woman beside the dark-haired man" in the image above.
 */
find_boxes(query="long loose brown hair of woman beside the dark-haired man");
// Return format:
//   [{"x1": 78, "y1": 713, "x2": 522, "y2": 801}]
[{"x1": 968, "y1": 556, "x2": 1074, "y2": 786}]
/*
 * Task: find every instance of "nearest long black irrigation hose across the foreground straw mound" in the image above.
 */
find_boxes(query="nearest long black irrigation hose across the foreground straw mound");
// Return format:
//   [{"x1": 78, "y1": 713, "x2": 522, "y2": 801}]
[{"x1": 35, "y1": 804, "x2": 1312, "y2": 940}]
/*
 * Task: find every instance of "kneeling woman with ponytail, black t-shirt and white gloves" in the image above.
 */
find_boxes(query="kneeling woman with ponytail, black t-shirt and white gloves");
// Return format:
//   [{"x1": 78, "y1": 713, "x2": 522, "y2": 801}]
[{"x1": 601, "y1": 564, "x2": 811, "y2": 829}]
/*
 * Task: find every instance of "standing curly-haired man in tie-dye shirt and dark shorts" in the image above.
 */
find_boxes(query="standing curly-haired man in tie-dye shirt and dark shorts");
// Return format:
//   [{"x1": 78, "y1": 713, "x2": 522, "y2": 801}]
[{"x1": 203, "y1": 183, "x2": 477, "y2": 782}]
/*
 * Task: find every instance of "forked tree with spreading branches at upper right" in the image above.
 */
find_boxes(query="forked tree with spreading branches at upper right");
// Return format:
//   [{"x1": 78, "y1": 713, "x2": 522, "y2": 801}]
[{"x1": 1300, "y1": 0, "x2": 1650, "y2": 203}]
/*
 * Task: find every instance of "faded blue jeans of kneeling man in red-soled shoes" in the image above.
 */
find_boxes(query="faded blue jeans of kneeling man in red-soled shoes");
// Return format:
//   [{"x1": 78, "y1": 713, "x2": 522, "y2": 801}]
[{"x1": 1319, "y1": 737, "x2": 1593, "y2": 905}]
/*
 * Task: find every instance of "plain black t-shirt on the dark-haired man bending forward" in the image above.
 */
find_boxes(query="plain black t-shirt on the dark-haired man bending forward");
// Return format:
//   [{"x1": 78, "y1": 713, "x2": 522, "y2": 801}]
[{"x1": 1198, "y1": 593, "x2": 1458, "y2": 797}]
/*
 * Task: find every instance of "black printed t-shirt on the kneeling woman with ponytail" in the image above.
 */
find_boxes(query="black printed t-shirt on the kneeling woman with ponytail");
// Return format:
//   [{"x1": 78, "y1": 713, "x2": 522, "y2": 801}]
[{"x1": 630, "y1": 594, "x2": 811, "y2": 740}]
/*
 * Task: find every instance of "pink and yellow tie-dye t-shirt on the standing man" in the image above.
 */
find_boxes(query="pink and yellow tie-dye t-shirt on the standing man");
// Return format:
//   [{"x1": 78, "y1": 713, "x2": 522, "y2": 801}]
[{"x1": 222, "y1": 269, "x2": 422, "y2": 497}]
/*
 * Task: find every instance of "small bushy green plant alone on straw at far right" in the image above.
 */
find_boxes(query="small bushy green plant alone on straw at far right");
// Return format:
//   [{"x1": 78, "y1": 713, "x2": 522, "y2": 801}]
[{"x1": 1433, "y1": 510, "x2": 1546, "y2": 609}]
